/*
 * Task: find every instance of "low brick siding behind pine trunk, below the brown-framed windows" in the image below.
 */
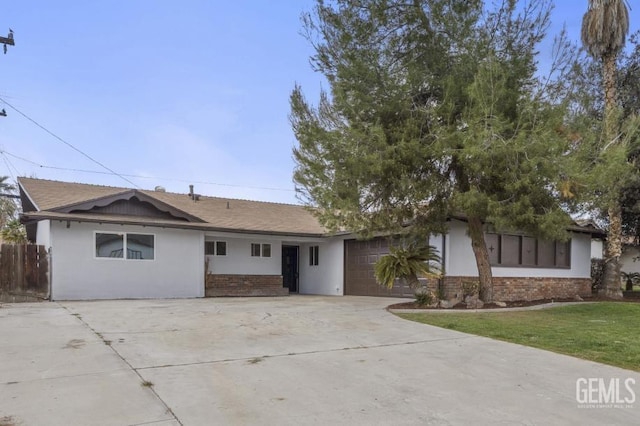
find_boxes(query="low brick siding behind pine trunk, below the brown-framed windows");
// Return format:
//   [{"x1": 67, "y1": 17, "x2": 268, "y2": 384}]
[{"x1": 420, "y1": 277, "x2": 591, "y2": 302}]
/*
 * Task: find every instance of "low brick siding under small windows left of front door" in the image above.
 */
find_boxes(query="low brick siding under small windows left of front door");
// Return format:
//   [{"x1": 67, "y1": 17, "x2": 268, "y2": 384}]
[{"x1": 205, "y1": 274, "x2": 289, "y2": 297}]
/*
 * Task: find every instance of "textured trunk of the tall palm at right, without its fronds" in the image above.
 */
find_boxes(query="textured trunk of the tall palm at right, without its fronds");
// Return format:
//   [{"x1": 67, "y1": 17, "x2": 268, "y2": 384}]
[{"x1": 598, "y1": 54, "x2": 622, "y2": 299}]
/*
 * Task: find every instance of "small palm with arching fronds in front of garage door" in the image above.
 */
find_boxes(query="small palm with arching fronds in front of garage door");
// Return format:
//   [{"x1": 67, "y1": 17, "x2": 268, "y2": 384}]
[{"x1": 374, "y1": 244, "x2": 441, "y2": 291}]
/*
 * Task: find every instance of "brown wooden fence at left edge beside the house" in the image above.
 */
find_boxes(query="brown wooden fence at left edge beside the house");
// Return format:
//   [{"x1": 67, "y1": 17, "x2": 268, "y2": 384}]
[{"x1": 0, "y1": 244, "x2": 49, "y2": 303}]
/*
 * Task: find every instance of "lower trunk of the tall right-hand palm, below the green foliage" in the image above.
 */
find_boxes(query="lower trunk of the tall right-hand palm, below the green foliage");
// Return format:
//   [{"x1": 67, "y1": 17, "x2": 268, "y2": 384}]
[{"x1": 598, "y1": 200, "x2": 623, "y2": 299}]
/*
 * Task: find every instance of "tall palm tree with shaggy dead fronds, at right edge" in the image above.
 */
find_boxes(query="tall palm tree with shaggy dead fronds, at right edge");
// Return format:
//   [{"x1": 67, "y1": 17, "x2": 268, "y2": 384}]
[{"x1": 581, "y1": 0, "x2": 629, "y2": 299}]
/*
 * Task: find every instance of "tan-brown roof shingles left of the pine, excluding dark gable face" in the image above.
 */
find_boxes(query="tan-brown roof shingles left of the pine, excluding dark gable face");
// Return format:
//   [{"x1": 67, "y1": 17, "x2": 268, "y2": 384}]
[{"x1": 18, "y1": 178, "x2": 326, "y2": 235}]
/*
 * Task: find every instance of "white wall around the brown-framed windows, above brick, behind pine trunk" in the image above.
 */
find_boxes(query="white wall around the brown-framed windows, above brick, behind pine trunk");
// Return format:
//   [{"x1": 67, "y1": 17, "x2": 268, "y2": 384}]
[{"x1": 445, "y1": 220, "x2": 591, "y2": 278}]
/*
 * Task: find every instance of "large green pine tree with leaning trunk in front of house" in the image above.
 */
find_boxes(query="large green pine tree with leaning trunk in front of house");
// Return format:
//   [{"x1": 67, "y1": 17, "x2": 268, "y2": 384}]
[{"x1": 291, "y1": 0, "x2": 569, "y2": 302}]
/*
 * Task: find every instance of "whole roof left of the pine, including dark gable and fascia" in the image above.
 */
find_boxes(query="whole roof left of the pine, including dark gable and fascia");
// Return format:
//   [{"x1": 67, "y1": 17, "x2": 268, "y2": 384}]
[{"x1": 18, "y1": 178, "x2": 326, "y2": 236}]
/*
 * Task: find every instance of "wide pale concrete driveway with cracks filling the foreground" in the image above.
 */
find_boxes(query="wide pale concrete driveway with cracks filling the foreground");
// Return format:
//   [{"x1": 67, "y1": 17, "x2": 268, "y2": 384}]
[{"x1": 0, "y1": 296, "x2": 640, "y2": 426}]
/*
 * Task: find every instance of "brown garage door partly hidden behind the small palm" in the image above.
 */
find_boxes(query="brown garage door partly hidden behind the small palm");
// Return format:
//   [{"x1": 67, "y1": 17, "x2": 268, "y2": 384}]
[{"x1": 344, "y1": 238, "x2": 413, "y2": 297}]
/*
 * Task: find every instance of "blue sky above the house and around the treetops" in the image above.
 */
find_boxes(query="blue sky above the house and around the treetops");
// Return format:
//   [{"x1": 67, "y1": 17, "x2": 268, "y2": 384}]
[{"x1": 0, "y1": 0, "x2": 640, "y2": 203}]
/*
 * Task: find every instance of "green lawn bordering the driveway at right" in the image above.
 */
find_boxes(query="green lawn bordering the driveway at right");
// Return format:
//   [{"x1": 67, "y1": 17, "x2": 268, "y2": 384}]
[{"x1": 398, "y1": 302, "x2": 640, "y2": 371}]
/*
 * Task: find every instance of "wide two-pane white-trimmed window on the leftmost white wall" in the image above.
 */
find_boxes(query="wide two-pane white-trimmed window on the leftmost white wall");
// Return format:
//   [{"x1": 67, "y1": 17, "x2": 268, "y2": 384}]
[{"x1": 94, "y1": 232, "x2": 155, "y2": 260}]
